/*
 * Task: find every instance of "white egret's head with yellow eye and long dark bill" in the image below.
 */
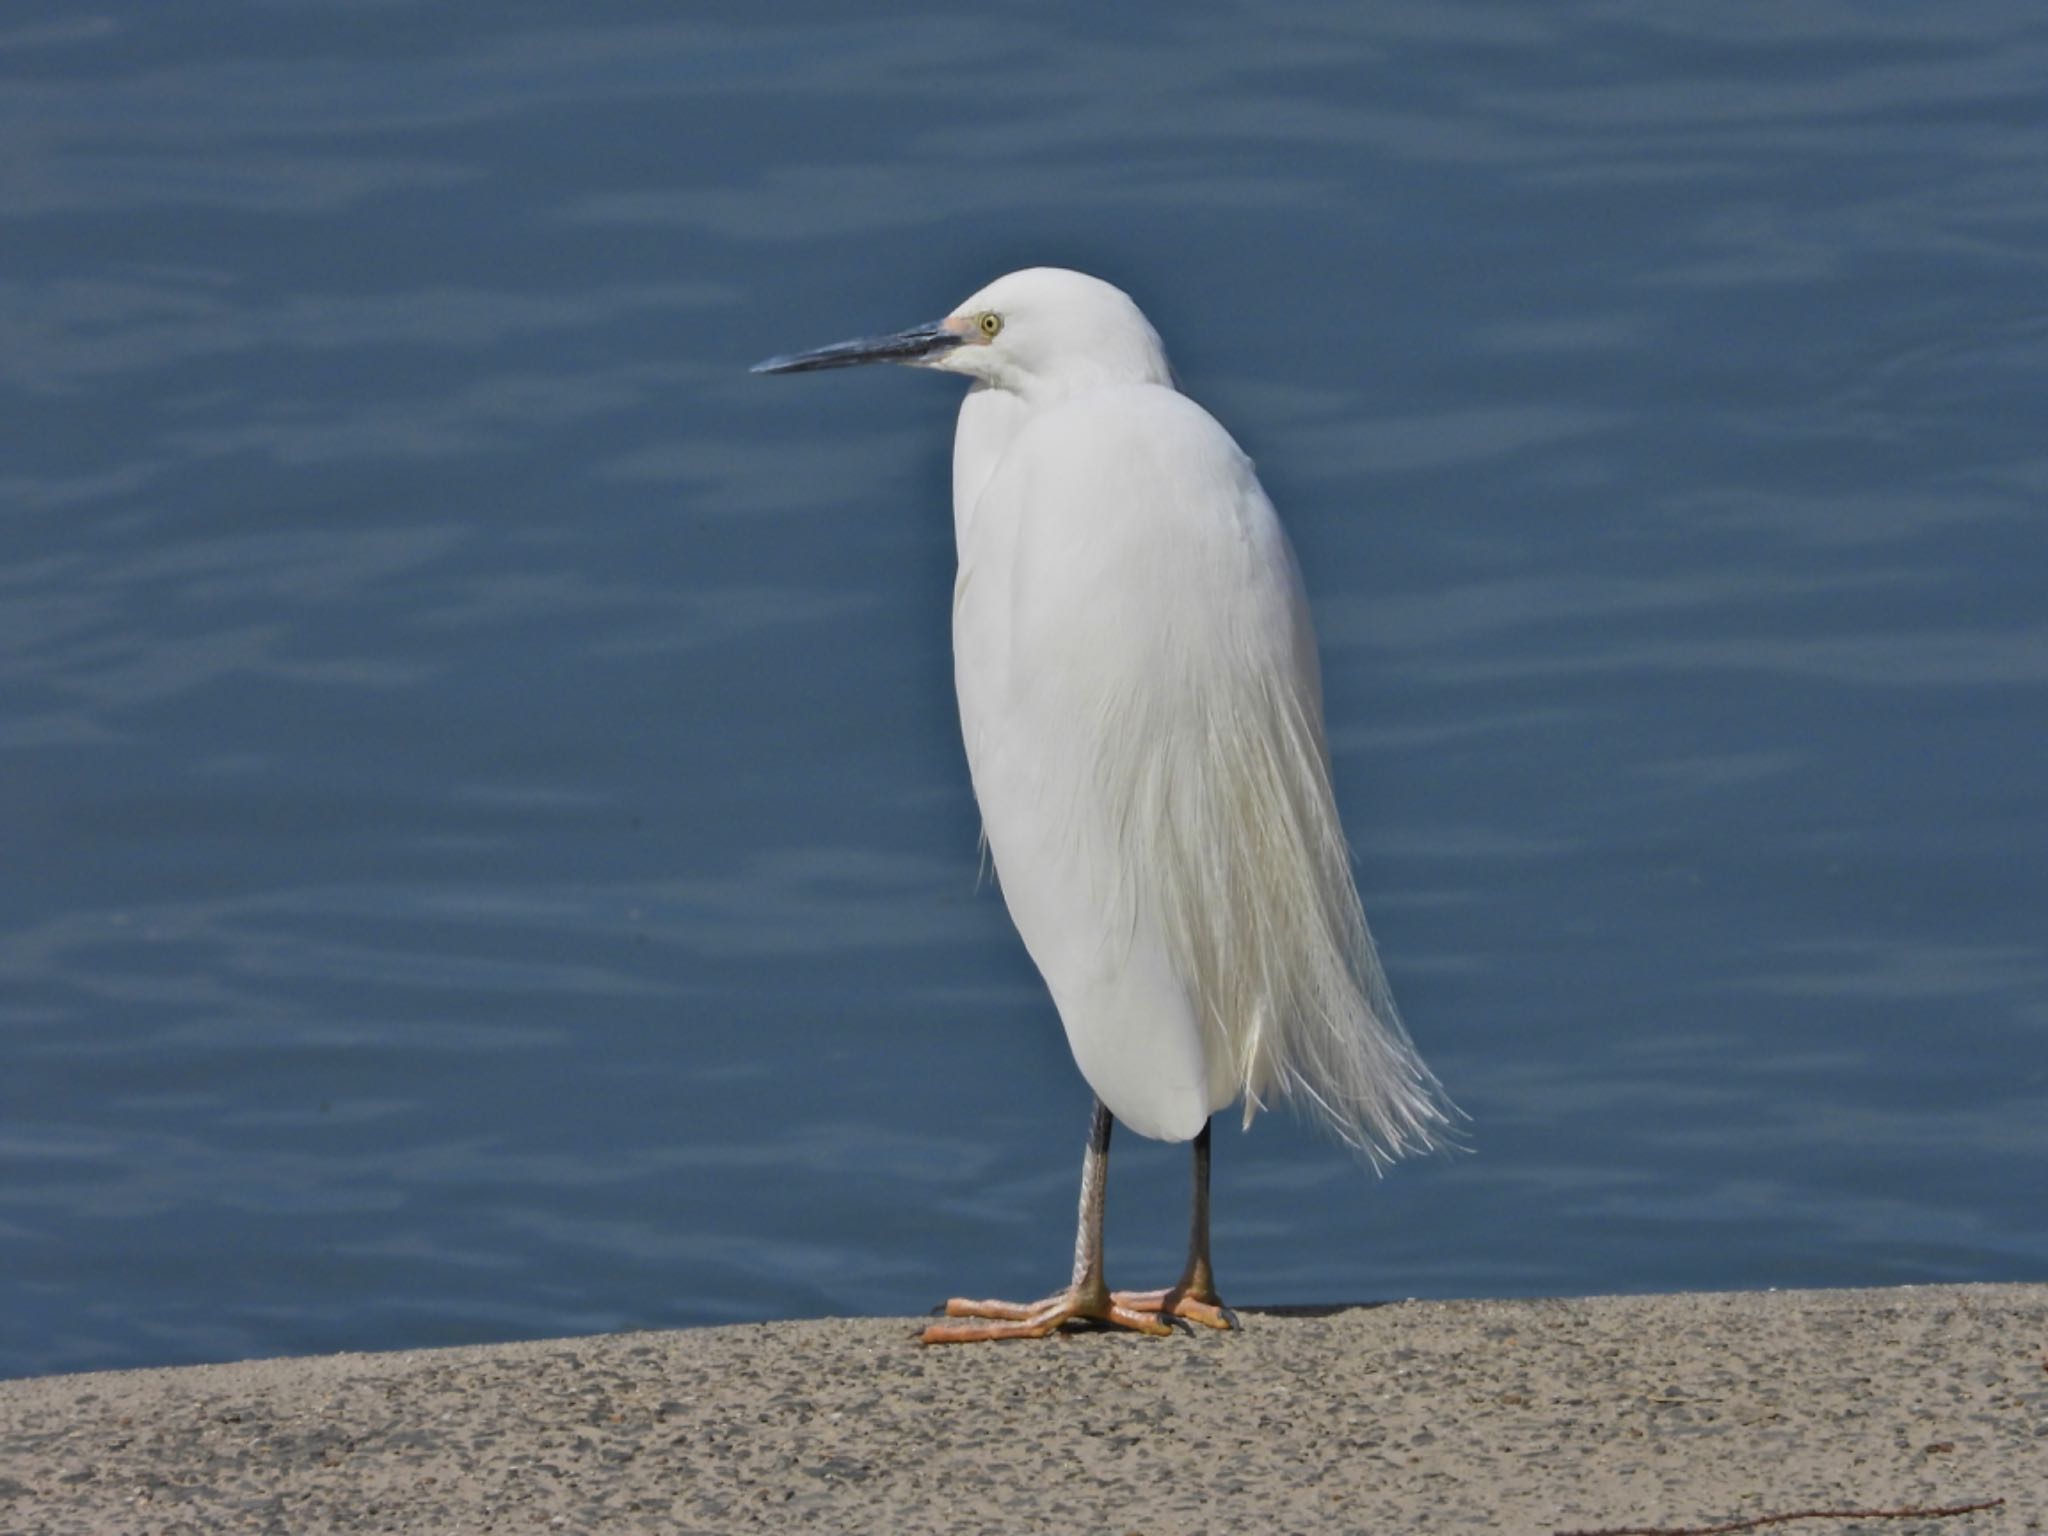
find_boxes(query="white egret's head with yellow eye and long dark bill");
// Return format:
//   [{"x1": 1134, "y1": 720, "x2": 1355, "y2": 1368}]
[{"x1": 754, "y1": 266, "x2": 1174, "y2": 399}]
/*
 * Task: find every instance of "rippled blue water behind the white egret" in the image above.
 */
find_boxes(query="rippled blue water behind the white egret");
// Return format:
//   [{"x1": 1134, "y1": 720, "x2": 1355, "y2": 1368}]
[{"x1": 0, "y1": 0, "x2": 2048, "y2": 1374}]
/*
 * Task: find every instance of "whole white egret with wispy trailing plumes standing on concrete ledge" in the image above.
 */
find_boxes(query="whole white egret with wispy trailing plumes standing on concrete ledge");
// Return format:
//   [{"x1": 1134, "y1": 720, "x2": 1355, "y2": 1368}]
[{"x1": 754, "y1": 268, "x2": 1454, "y2": 1343}]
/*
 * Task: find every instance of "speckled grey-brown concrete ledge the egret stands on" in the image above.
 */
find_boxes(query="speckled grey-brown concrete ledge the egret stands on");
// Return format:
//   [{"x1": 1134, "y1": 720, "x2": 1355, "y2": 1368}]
[{"x1": 0, "y1": 1284, "x2": 2048, "y2": 1536}]
